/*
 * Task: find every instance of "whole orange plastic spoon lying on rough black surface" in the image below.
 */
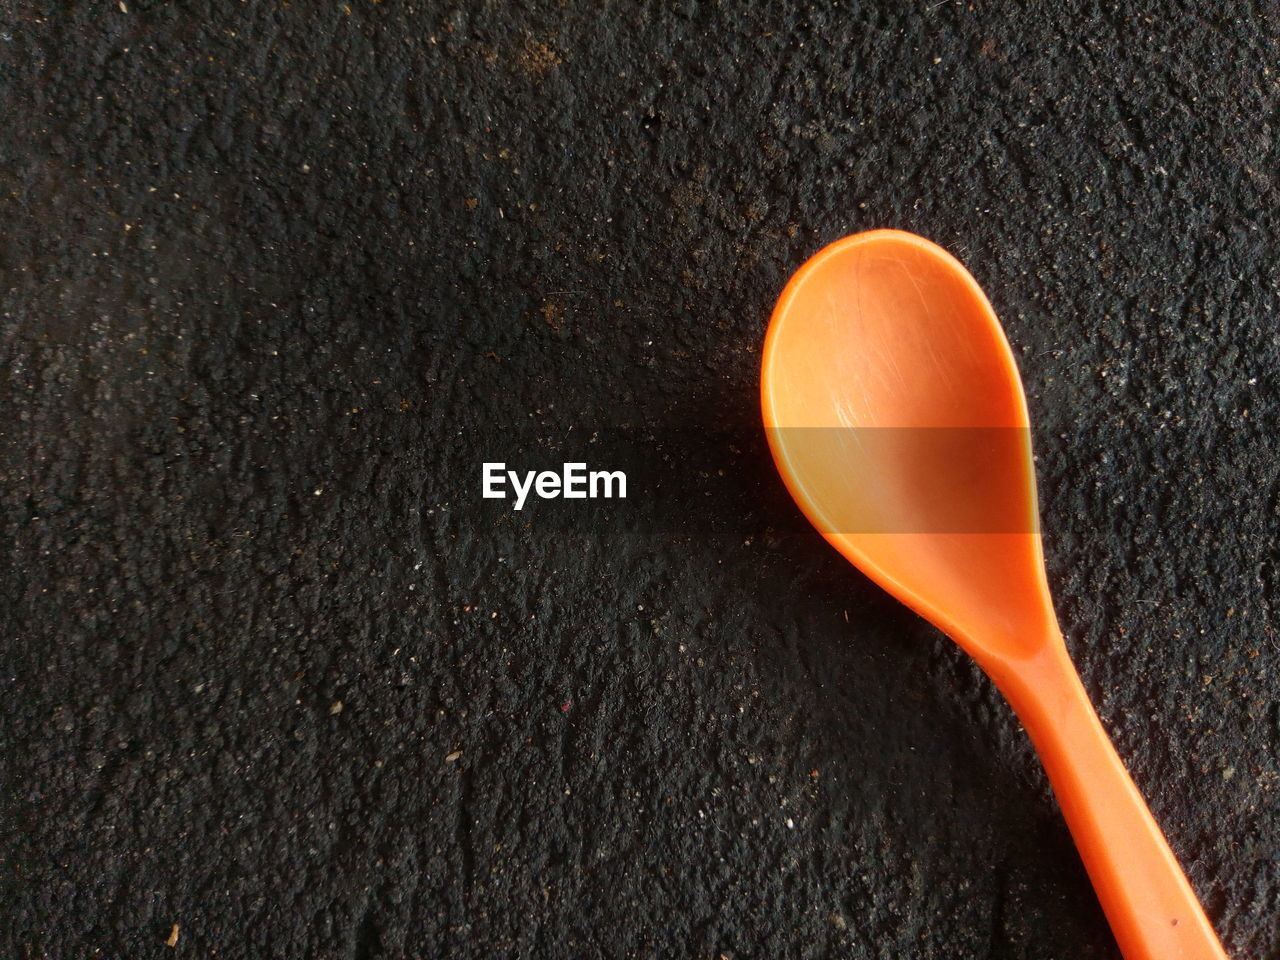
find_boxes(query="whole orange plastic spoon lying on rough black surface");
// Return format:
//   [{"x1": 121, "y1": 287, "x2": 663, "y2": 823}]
[{"x1": 762, "y1": 230, "x2": 1226, "y2": 960}]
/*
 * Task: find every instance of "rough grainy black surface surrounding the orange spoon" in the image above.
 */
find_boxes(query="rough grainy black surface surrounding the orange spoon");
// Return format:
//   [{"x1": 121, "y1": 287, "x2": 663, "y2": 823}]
[{"x1": 0, "y1": 0, "x2": 1280, "y2": 960}]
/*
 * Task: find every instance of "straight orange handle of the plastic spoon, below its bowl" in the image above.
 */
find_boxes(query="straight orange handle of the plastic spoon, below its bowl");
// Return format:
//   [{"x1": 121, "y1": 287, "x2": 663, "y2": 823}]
[{"x1": 1000, "y1": 643, "x2": 1226, "y2": 960}]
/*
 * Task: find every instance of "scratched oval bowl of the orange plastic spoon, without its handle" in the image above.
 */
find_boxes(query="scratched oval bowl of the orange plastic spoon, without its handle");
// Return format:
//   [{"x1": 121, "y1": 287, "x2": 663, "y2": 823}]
[{"x1": 763, "y1": 230, "x2": 1053, "y2": 662}]
